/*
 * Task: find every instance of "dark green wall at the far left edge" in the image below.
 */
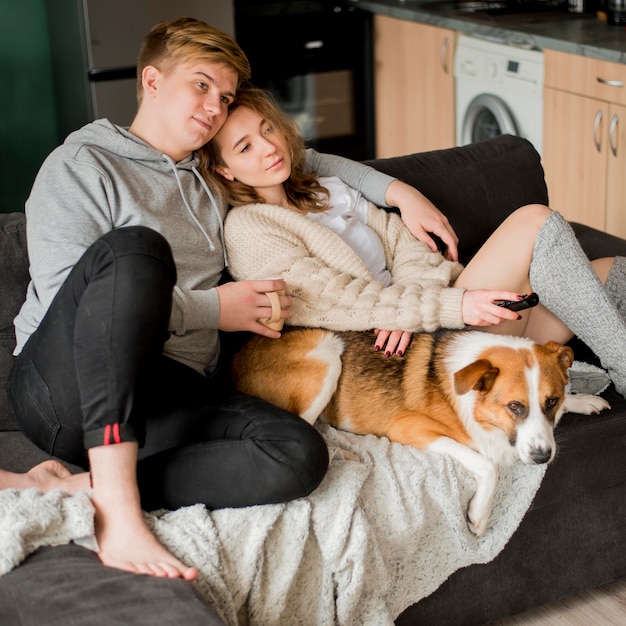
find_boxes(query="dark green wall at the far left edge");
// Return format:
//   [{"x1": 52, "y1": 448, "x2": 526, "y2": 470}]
[{"x1": 0, "y1": 0, "x2": 59, "y2": 213}]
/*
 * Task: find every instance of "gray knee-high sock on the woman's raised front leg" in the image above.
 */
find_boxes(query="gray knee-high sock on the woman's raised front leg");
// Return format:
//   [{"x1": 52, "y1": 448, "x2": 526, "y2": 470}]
[{"x1": 530, "y1": 212, "x2": 626, "y2": 395}]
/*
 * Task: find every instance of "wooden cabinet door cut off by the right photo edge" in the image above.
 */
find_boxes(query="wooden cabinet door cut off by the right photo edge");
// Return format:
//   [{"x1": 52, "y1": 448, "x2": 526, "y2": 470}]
[{"x1": 606, "y1": 104, "x2": 626, "y2": 238}]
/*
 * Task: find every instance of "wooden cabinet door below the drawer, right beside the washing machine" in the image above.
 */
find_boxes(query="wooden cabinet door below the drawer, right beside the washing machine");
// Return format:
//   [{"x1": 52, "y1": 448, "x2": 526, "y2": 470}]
[{"x1": 542, "y1": 88, "x2": 609, "y2": 230}]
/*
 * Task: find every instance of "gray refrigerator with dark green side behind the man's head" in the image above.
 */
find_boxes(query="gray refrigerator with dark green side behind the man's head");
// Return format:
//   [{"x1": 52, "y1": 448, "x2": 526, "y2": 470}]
[{"x1": 46, "y1": 0, "x2": 235, "y2": 141}]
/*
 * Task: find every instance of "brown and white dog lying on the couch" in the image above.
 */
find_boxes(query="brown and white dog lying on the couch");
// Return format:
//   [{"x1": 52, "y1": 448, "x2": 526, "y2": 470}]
[{"x1": 231, "y1": 328, "x2": 609, "y2": 536}]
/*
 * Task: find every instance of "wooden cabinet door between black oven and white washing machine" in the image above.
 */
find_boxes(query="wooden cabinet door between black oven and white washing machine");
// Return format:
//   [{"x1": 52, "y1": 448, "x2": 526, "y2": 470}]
[{"x1": 374, "y1": 15, "x2": 454, "y2": 158}]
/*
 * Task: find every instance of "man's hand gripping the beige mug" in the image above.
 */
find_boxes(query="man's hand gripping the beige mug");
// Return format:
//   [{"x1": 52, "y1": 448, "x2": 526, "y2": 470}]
[{"x1": 216, "y1": 278, "x2": 293, "y2": 339}]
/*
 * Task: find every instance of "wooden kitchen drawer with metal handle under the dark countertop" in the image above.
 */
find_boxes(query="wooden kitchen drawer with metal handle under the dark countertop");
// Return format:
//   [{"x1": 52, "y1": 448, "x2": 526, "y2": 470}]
[{"x1": 544, "y1": 50, "x2": 626, "y2": 104}]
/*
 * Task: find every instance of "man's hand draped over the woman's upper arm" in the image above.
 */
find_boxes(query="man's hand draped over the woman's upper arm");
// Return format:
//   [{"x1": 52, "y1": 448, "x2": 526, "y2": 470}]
[{"x1": 385, "y1": 180, "x2": 459, "y2": 261}]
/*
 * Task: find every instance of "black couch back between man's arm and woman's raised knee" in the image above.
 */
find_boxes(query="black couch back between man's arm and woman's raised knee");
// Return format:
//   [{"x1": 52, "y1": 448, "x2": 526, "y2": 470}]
[{"x1": 366, "y1": 135, "x2": 548, "y2": 263}]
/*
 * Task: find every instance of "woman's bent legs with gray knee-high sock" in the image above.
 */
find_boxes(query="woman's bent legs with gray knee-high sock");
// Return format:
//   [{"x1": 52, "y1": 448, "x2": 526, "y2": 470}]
[{"x1": 456, "y1": 205, "x2": 626, "y2": 395}]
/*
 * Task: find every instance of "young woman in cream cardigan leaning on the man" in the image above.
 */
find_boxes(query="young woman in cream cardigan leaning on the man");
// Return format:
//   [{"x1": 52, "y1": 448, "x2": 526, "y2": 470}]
[{"x1": 203, "y1": 88, "x2": 626, "y2": 394}]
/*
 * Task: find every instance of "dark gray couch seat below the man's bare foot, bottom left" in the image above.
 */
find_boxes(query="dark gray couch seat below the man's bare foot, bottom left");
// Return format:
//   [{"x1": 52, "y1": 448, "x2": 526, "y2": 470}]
[{"x1": 0, "y1": 544, "x2": 224, "y2": 626}]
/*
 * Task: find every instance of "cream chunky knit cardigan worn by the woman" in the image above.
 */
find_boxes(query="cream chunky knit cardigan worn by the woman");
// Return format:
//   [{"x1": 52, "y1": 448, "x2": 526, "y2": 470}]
[{"x1": 225, "y1": 204, "x2": 464, "y2": 332}]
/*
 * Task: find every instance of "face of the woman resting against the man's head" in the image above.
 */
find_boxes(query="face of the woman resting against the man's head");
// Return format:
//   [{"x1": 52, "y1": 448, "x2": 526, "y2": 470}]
[{"x1": 214, "y1": 106, "x2": 291, "y2": 190}]
